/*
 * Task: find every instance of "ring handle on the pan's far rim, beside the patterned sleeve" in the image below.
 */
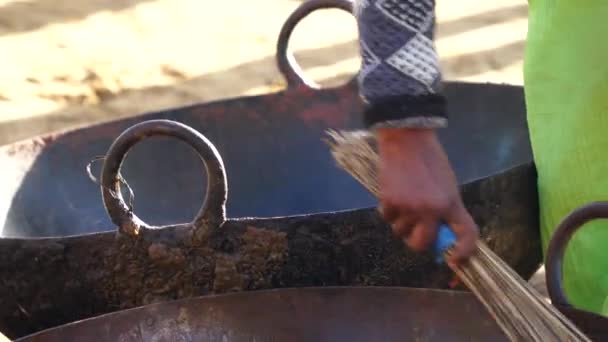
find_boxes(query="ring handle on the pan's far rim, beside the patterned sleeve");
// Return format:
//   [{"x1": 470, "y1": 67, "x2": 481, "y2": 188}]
[{"x1": 276, "y1": 0, "x2": 354, "y2": 89}]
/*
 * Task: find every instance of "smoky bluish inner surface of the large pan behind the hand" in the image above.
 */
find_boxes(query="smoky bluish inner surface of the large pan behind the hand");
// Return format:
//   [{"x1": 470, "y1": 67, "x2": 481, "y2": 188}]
[{"x1": 0, "y1": 83, "x2": 535, "y2": 237}]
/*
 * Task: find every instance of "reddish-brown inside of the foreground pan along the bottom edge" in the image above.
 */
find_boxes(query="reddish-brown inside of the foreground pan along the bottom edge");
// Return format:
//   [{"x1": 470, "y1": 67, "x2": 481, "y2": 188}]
[{"x1": 18, "y1": 288, "x2": 508, "y2": 342}]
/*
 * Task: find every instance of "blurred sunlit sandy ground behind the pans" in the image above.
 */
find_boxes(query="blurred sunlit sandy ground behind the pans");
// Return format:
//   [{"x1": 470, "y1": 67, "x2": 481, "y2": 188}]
[{"x1": 0, "y1": 0, "x2": 527, "y2": 144}]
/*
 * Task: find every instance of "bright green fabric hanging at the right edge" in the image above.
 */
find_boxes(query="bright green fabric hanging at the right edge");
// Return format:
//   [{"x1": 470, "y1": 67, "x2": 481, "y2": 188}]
[{"x1": 524, "y1": 0, "x2": 608, "y2": 315}]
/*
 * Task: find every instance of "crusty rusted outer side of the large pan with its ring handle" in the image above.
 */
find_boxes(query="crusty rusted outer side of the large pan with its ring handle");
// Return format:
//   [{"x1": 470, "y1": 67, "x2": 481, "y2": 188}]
[{"x1": 0, "y1": 117, "x2": 541, "y2": 337}]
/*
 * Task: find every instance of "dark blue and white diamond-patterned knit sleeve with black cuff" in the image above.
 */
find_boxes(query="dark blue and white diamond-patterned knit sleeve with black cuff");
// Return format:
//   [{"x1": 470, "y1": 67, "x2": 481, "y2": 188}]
[{"x1": 354, "y1": 0, "x2": 447, "y2": 130}]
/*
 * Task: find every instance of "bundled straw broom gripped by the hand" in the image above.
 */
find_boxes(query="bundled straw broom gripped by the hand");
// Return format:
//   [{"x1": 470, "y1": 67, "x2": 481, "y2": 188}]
[{"x1": 327, "y1": 131, "x2": 591, "y2": 342}]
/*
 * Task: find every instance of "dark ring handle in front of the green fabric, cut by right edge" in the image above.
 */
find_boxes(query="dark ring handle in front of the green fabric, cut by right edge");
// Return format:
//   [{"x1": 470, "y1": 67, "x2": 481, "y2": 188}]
[{"x1": 545, "y1": 202, "x2": 608, "y2": 307}]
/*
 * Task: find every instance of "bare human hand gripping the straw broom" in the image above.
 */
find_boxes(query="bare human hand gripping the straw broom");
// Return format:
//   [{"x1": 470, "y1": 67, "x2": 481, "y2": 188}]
[{"x1": 378, "y1": 128, "x2": 479, "y2": 265}]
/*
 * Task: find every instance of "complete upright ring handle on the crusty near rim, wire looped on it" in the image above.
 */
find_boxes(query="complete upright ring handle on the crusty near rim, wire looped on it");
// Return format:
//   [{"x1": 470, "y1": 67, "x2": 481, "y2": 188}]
[{"x1": 101, "y1": 120, "x2": 228, "y2": 236}]
